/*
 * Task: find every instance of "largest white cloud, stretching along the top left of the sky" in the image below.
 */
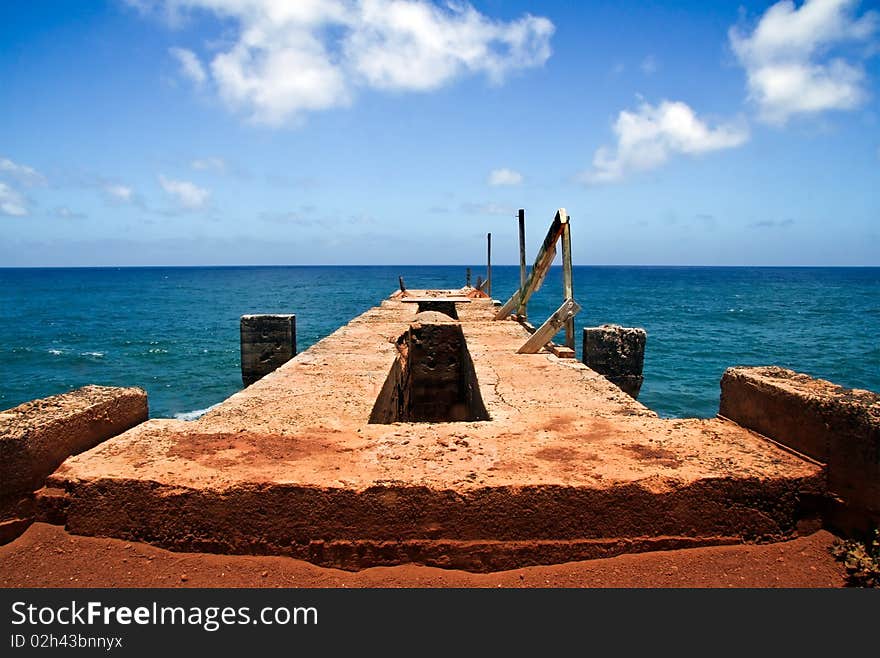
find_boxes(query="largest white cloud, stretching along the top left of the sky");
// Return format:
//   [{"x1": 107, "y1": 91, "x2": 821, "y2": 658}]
[{"x1": 149, "y1": 0, "x2": 554, "y2": 125}]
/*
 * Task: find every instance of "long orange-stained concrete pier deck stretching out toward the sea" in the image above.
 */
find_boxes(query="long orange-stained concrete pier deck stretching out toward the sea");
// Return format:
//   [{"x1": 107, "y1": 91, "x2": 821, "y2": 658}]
[{"x1": 41, "y1": 291, "x2": 824, "y2": 571}]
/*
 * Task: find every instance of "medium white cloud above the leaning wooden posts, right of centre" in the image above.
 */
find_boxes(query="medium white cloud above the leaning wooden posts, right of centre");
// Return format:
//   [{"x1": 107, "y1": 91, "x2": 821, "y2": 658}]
[{"x1": 580, "y1": 101, "x2": 749, "y2": 183}]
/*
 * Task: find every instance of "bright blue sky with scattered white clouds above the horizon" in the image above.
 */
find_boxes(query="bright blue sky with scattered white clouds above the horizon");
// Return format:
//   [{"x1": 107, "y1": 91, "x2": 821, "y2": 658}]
[{"x1": 0, "y1": 0, "x2": 880, "y2": 266}]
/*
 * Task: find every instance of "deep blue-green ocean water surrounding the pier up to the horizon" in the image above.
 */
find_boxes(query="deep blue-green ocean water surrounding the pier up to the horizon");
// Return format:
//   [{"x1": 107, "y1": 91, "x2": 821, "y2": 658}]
[{"x1": 0, "y1": 266, "x2": 880, "y2": 418}]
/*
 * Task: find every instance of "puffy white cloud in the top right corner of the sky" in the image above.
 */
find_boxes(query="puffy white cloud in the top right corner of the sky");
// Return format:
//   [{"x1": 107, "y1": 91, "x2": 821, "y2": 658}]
[{"x1": 729, "y1": 0, "x2": 878, "y2": 124}]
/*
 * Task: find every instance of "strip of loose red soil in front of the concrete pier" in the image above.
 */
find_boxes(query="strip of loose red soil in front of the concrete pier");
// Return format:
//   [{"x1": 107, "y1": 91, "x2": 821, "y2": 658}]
[{"x1": 0, "y1": 523, "x2": 844, "y2": 587}]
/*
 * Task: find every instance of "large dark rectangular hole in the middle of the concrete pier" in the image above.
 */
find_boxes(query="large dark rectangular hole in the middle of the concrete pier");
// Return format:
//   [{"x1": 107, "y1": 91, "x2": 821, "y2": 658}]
[{"x1": 370, "y1": 311, "x2": 490, "y2": 423}]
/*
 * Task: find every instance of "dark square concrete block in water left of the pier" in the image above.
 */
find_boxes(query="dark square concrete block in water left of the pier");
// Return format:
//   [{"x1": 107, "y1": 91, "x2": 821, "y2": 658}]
[{"x1": 241, "y1": 314, "x2": 296, "y2": 386}]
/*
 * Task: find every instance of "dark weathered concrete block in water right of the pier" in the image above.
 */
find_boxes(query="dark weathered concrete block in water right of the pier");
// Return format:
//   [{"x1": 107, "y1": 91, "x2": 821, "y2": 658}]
[{"x1": 583, "y1": 324, "x2": 648, "y2": 398}]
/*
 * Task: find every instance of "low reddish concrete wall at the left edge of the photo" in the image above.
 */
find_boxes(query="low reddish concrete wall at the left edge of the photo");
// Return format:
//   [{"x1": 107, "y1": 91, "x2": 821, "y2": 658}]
[{"x1": 0, "y1": 386, "x2": 148, "y2": 499}]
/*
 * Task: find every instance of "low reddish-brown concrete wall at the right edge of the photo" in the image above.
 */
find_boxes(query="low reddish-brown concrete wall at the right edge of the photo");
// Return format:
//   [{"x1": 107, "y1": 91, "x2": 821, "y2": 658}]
[{"x1": 719, "y1": 367, "x2": 880, "y2": 529}]
